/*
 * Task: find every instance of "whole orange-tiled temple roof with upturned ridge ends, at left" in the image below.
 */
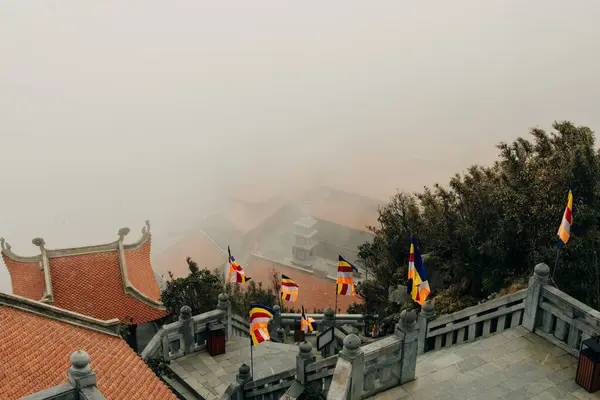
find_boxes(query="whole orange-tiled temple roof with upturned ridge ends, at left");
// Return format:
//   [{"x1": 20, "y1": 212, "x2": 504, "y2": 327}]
[{"x1": 0, "y1": 221, "x2": 167, "y2": 324}]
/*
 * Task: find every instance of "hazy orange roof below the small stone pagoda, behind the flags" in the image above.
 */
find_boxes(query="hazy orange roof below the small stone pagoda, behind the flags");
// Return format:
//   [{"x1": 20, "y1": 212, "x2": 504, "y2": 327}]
[{"x1": 242, "y1": 255, "x2": 362, "y2": 313}]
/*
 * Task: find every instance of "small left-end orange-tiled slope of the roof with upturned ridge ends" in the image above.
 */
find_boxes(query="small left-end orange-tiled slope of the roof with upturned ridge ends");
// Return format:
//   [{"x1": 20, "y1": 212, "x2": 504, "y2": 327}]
[{"x1": 2, "y1": 253, "x2": 46, "y2": 300}]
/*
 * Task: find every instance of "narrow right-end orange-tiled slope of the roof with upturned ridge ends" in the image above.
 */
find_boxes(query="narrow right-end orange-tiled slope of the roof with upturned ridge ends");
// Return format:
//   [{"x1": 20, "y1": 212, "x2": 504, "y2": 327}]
[{"x1": 125, "y1": 240, "x2": 160, "y2": 301}]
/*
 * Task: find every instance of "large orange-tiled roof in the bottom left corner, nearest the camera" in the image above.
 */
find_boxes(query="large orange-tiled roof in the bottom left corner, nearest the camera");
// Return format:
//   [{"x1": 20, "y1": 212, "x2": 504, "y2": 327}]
[{"x1": 0, "y1": 293, "x2": 177, "y2": 400}]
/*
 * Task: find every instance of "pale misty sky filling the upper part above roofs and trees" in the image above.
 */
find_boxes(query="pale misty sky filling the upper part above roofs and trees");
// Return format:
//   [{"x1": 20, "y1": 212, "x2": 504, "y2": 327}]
[{"x1": 0, "y1": 0, "x2": 600, "y2": 290}]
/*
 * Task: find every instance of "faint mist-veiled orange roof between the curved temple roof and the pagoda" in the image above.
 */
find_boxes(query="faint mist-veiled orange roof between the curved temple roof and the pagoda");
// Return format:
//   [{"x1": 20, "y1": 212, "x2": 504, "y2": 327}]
[{"x1": 153, "y1": 231, "x2": 227, "y2": 279}]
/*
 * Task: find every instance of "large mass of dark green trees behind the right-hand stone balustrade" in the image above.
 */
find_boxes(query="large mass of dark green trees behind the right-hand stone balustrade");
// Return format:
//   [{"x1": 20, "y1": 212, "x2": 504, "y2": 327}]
[{"x1": 354, "y1": 122, "x2": 600, "y2": 315}]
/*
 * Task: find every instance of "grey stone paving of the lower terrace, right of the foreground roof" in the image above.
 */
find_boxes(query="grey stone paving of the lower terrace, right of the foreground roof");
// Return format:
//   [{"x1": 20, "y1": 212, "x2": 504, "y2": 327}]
[{"x1": 170, "y1": 337, "x2": 302, "y2": 400}]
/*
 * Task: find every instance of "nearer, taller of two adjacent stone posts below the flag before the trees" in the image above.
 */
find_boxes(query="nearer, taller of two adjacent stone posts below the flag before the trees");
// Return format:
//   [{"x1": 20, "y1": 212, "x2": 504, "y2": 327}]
[{"x1": 394, "y1": 310, "x2": 419, "y2": 385}]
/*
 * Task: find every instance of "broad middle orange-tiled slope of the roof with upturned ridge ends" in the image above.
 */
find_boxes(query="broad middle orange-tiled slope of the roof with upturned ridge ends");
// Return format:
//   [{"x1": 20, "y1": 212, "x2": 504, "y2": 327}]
[{"x1": 50, "y1": 251, "x2": 167, "y2": 324}]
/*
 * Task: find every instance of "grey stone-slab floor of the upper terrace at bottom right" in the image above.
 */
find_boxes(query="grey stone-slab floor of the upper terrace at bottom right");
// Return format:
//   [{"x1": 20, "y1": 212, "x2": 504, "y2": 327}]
[{"x1": 371, "y1": 327, "x2": 600, "y2": 400}]
